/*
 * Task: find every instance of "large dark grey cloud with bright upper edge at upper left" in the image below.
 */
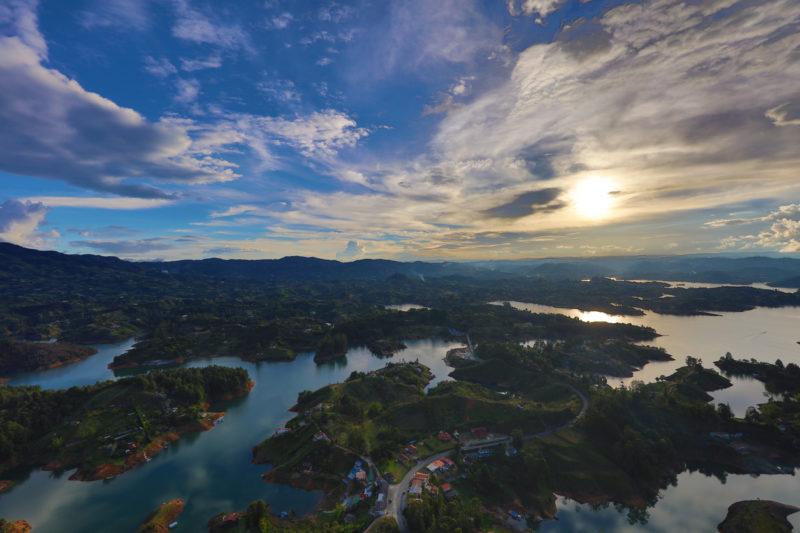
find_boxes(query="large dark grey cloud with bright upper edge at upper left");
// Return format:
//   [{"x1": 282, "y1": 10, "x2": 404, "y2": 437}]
[{"x1": 0, "y1": 8, "x2": 237, "y2": 198}]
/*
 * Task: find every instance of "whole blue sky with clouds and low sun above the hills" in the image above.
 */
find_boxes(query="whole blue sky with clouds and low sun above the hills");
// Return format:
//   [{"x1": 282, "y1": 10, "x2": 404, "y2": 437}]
[{"x1": 0, "y1": 0, "x2": 800, "y2": 260}]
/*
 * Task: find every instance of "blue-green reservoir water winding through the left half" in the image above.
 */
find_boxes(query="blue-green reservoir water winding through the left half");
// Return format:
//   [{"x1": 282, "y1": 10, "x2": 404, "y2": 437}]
[{"x1": 0, "y1": 340, "x2": 459, "y2": 533}]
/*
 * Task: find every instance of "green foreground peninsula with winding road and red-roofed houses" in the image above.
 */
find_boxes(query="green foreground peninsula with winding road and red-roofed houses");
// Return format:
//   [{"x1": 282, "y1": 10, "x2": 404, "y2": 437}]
[{"x1": 228, "y1": 340, "x2": 800, "y2": 533}]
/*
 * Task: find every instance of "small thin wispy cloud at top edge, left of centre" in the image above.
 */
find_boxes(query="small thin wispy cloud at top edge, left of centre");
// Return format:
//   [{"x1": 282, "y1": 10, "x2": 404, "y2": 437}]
[{"x1": 172, "y1": 0, "x2": 254, "y2": 53}]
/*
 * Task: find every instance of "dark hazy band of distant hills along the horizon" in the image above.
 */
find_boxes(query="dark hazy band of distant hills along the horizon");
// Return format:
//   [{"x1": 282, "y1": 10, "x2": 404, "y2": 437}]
[{"x1": 0, "y1": 243, "x2": 800, "y2": 287}]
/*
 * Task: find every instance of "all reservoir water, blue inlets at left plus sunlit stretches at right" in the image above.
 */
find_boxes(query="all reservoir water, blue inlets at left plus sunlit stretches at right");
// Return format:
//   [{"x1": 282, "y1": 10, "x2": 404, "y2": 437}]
[{"x1": 0, "y1": 302, "x2": 800, "y2": 533}]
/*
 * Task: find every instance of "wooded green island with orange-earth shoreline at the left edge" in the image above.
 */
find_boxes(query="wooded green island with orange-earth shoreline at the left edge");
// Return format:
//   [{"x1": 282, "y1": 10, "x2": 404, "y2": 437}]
[{"x1": 0, "y1": 366, "x2": 252, "y2": 481}]
